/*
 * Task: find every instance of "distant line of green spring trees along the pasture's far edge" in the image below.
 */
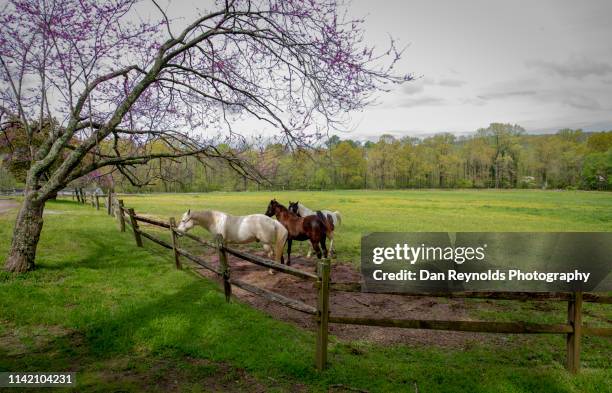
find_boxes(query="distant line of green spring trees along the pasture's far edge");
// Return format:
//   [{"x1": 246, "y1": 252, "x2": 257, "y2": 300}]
[{"x1": 0, "y1": 123, "x2": 612, "y2": 192}]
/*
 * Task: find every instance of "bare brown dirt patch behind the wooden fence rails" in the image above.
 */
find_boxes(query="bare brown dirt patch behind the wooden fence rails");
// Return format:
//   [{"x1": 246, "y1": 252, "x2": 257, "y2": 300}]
[{"x1": 196, "y1": 248, "x2": 504, "y2": 348}]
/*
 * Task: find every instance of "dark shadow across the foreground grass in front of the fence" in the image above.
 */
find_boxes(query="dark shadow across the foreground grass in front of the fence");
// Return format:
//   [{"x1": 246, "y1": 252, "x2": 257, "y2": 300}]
[{"x1": 0, "y1": 270, "x2": 588, "y2": 392}]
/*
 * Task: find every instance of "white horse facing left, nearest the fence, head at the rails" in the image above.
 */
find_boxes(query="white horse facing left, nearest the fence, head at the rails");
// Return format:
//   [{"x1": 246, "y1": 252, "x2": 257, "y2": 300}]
[{"x1": 176, "y1": 209, "x2": 287, "y2": 263}]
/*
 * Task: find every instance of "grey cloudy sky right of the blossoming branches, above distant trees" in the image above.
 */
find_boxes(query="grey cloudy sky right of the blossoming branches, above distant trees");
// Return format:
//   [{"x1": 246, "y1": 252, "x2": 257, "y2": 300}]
[{"x1": 157, "y1": 0, "x2": 612, "y2": 139}]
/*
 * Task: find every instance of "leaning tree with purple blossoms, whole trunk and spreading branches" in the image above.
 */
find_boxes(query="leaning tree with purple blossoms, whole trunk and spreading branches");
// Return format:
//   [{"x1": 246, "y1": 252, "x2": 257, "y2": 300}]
[{"x1": 0, "y1": 0, "x2": 410, "y2": 272}]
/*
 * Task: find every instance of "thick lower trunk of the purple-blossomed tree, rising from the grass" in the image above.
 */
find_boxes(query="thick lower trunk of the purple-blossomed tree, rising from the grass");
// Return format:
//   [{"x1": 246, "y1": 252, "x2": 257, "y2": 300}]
[{"x1": 4, "y1": 191, "x2": 45, "y2": 273}]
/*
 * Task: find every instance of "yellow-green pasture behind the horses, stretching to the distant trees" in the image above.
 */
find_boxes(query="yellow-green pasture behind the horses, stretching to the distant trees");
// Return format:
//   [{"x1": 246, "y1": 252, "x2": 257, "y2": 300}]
[{"x1": 120, "y1": 190, "x2": 612, "y2": 263}]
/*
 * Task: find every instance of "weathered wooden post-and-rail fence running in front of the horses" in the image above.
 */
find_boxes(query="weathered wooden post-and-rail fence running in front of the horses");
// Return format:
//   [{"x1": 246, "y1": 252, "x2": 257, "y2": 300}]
[{"x1": 70, "y1": 193, "x2": 612, "y2": 373}]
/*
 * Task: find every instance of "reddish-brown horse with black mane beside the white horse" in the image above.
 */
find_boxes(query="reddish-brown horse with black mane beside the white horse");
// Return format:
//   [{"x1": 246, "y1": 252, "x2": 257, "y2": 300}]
[{"x1": 266, "y1": 199, "x2": 334, "y2": 265}]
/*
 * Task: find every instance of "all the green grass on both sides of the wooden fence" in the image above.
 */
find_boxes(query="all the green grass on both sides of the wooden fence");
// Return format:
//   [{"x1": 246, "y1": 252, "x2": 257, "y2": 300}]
[{"x1": 0, "y1": 191, "x2": 612, "y2": 392}]
